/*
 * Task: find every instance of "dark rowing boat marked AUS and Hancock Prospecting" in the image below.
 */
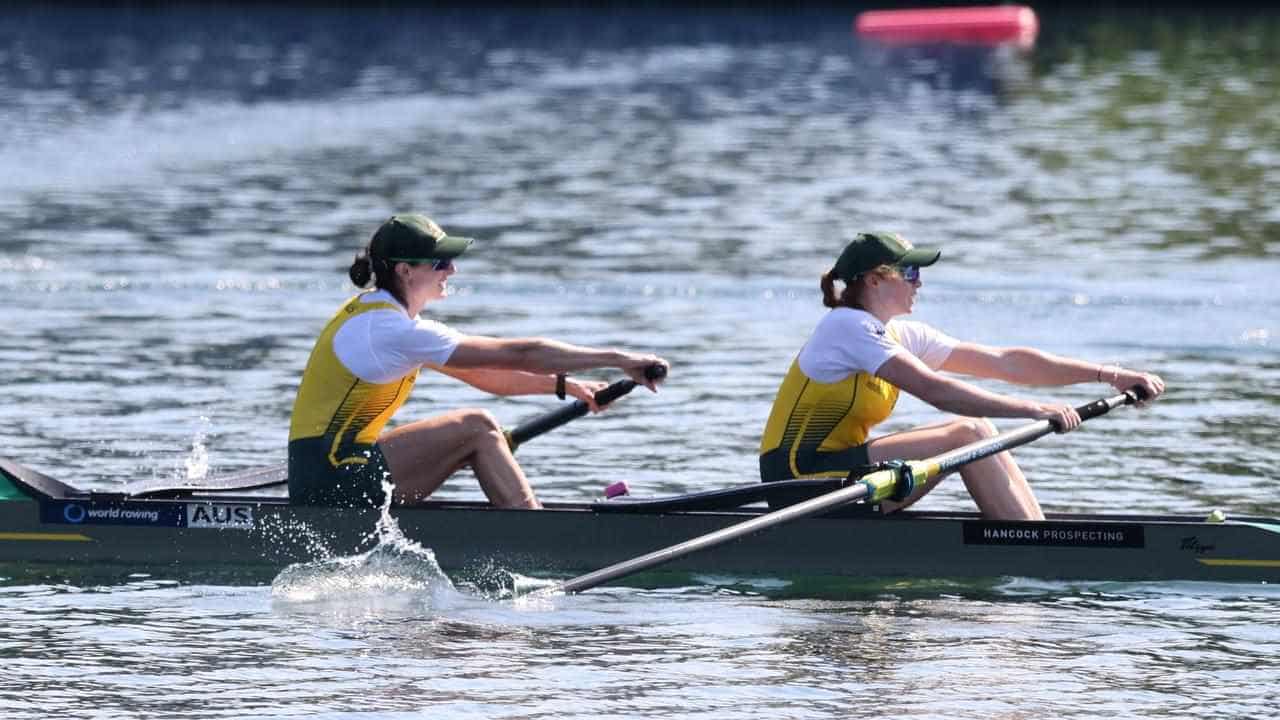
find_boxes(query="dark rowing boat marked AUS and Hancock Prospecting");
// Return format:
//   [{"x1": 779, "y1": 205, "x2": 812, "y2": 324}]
[{"x1": 0, "y1": 457, "x2": 1280, "y2": 582}]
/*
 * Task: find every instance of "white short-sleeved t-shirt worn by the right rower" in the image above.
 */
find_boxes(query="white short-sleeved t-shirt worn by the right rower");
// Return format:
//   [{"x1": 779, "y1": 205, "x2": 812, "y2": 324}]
[{"x1": 799, "y1": 307, "x2": 960, "y2": 383}]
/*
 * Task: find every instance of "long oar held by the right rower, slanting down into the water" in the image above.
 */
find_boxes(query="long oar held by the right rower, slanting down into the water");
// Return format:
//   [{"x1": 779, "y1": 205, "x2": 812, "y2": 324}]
[{"x1": 538, "y1": 387, "x2": 1143, "y2": 594}]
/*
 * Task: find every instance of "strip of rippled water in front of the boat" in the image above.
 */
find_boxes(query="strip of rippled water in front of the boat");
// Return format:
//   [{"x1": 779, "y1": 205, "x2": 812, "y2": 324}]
[{"x1": 0, "y1": 579, "x2": 1277, "y2": 717}]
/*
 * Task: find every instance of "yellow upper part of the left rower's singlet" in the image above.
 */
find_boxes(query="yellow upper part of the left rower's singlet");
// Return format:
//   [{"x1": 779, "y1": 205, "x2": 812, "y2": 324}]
[{"x1": 289, "y1": 295, "x2": 417, "y2": 468}]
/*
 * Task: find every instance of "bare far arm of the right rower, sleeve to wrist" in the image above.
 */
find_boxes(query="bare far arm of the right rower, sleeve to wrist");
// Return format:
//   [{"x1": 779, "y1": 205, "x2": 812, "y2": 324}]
[{"x1": 942, "y1": 342, "x2": 1098, "y2": 386}]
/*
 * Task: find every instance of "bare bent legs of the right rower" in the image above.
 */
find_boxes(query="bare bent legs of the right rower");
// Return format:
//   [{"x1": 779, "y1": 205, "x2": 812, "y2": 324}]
[{"x1": 867, "y1": 418, "x2": 1044, "y2": 520}]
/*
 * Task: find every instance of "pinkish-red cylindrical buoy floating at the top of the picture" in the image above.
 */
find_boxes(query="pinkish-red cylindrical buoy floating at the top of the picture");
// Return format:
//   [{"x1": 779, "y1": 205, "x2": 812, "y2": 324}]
[{"x1": 854, "y1": 5, "x2": 1039, "y2": 47}]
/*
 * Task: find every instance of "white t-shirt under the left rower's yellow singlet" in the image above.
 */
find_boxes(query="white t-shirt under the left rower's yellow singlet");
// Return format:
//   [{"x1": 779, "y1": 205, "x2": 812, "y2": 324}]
[{"x1": 333, "y1": 290, "x2": 466, "y2": 383}]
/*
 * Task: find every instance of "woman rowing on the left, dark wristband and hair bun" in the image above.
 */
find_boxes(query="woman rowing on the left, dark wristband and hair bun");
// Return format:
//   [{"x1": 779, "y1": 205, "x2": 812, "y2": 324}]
[{"x1": 289, "y1": 215, "x2": 667, "y2": 507}]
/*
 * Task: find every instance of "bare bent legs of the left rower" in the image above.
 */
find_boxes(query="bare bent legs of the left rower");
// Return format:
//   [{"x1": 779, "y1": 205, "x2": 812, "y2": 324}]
[{"x1": 378, "y1": 410, "x2": 541, "y2": 507}]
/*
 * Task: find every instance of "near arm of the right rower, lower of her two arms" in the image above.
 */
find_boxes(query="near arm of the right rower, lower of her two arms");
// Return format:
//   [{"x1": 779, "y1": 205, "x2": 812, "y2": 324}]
[{"x1": 876, "y1": 352, "x2": 1079, "y2": 427}]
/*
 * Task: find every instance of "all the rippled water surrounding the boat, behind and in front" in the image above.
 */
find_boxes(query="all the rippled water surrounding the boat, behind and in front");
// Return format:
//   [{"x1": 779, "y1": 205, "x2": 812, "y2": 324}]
[{"x1": 0, "y1": 5, "x2": 1280, "y2": 717}]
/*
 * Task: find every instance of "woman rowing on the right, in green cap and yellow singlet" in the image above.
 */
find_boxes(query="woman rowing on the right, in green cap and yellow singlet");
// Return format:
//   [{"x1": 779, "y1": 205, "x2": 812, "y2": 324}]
[{"x1": 760, "y1": 232, "x2": 1165, "y2": 520}]
